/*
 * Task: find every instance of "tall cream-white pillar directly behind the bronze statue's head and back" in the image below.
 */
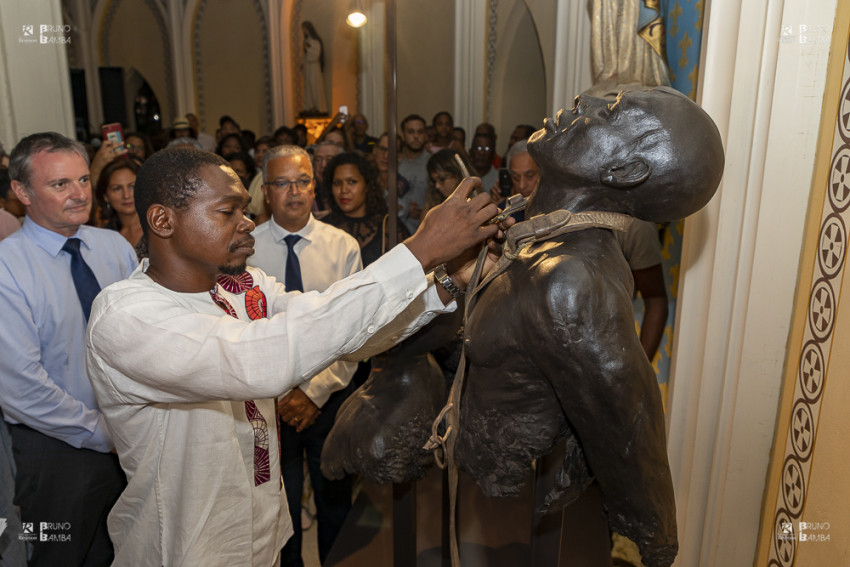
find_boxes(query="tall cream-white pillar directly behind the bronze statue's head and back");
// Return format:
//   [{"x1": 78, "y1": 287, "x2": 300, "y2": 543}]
[{"x1": 668, "y1": 0, "x2": 843, "y2": 566}]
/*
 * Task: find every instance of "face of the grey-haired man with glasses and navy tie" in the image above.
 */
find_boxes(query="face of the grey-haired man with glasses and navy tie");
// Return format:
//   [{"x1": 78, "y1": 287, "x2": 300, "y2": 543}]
[{"x1": 263, "y1": 155, "x2": 316, "y2": 232}]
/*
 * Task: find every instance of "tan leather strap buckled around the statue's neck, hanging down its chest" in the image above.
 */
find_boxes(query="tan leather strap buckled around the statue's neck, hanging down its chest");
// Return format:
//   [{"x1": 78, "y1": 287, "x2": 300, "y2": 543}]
[{"x1": 423, "y1": 209, "x2": 634, "y2": 567}]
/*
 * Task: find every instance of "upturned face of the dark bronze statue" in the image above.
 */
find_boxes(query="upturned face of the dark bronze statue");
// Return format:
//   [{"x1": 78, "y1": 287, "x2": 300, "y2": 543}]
[{"x1": 528, "y1": 91, "x2": 664, "y2": 186}]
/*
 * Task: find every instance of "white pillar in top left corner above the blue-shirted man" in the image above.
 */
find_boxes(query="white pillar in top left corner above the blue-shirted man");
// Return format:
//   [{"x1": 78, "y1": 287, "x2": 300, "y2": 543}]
[{"x1": 0, "y1": 0, "x2": 74, "y2": 150}]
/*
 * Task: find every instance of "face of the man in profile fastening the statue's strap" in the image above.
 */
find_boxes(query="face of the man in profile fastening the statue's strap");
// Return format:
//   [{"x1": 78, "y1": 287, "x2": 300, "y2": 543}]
[{"x1": 171, "y1": 165, "x2": 254, "y2": 277}]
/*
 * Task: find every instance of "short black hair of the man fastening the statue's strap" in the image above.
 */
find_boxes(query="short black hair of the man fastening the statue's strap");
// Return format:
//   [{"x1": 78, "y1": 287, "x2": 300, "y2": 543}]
[{"x1": 133, "y1": 147, "x2": 230, "y2": 235}]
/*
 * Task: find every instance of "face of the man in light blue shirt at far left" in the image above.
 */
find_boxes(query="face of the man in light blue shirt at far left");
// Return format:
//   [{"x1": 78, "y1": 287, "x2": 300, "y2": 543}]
[{"x1": 12, "y1": 150, "x2": 91, "y2": 236}]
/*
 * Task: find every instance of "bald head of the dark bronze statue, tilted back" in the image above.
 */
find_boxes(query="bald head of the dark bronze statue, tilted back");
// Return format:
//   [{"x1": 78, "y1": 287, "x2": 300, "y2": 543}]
[{"x1": 528, "y1": 87, "x2": 724, "y2": 222}]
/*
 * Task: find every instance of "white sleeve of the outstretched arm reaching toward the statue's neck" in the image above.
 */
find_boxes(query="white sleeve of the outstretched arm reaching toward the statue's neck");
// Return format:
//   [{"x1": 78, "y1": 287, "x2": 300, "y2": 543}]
[{"x1": 87, "y1": 246, "x2": 454, "y2": 405}]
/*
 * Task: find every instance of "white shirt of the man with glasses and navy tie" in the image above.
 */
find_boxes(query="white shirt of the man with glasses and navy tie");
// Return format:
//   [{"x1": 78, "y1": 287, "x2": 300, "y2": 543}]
[{"x1": 248, "y1": 214, "x2": 363, "y2": 408}]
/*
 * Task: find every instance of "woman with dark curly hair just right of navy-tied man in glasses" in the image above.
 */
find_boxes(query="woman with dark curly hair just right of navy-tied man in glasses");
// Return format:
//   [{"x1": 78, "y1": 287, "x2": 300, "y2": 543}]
[{"x1": 322, "y1": 152, "x2": 409, "y2": 267}]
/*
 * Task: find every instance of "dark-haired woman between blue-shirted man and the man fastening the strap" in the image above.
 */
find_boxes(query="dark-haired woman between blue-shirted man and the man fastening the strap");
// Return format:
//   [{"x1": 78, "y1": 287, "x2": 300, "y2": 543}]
[{"x1": 95, "y1": 157, "x2": 142, "y2": 247}]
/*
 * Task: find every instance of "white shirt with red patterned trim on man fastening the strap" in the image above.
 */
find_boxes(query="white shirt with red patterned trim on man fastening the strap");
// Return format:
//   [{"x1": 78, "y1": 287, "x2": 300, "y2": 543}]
[{"x1": 87, "y1": 245, "x2": 455, "y2": 567}]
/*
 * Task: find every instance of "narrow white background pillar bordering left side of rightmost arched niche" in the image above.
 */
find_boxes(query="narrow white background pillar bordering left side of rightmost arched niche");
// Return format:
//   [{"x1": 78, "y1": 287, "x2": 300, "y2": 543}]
[{"x1": 453, "y1": 0, "x2": 489, "y2": 136}]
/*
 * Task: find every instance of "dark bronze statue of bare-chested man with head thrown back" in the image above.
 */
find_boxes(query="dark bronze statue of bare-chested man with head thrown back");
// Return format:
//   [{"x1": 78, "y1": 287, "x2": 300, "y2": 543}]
[{"x1": 323, "y1": 87, "x2": 724, "y2": 567}]
